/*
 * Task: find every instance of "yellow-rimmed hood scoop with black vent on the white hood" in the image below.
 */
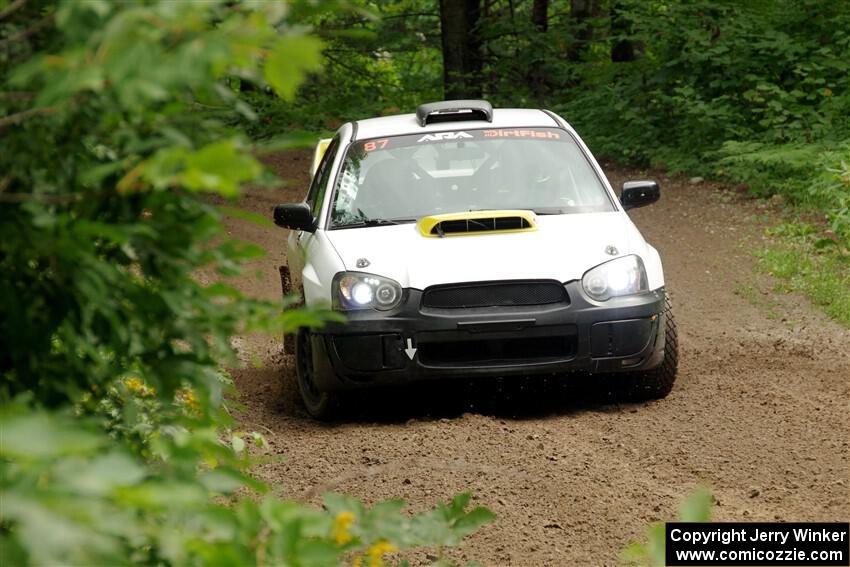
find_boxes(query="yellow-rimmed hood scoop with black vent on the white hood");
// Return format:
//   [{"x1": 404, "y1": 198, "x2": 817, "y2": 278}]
[{"x1": 416, "y1": 211, "x2": 537, "y2": 238}]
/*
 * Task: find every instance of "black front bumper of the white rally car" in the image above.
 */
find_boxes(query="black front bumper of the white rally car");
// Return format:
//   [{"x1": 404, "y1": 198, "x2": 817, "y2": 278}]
[{"x1": 312, "y1": 282, "x2": 665, "y2": 390}]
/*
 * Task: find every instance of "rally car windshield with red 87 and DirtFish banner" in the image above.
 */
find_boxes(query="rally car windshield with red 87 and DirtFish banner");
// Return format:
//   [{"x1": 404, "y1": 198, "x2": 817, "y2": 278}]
[{"x1": 331, "y1": 128, "x2": 615, "y2": 228}]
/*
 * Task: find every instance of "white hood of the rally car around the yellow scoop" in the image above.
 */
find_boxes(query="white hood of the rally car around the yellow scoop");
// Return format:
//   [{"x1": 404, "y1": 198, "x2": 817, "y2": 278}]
[{"x1": 326, "y1": 212, "x2": 646, "y2": 289}]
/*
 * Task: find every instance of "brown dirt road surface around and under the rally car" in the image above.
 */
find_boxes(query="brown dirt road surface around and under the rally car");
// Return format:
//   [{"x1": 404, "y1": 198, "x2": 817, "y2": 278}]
[{"x1": 228, "y1": 152, "x2": 850, "y2": 566}]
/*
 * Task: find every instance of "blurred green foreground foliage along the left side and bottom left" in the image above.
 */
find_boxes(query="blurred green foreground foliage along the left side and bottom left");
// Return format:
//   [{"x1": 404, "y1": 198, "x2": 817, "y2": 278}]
[{"x1": 0, "y1": 0, "x2": 491, "y2": 566}]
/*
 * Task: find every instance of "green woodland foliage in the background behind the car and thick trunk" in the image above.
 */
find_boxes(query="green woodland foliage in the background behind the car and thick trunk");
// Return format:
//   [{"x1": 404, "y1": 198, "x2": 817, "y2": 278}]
[{"x1": 243, "y1": 0, "x2": 850, "y2": 204}]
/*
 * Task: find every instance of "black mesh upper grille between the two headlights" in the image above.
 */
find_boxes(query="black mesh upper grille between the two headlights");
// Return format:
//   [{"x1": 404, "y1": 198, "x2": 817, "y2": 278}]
[{"x1": 422, "y1": 280, "x2": 569, "y2": 309}]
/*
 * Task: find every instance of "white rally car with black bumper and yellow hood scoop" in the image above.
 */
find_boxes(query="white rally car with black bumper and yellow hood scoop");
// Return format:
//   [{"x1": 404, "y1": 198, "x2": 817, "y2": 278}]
[{"x1": 274, "y1": 100, "x2": 678, "y2": 417}]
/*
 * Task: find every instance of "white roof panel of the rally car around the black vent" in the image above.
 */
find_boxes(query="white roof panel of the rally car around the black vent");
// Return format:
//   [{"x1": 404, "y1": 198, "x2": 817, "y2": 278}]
[{"x1": 353, "y1": 108, "x2": 561, "y2": 140}]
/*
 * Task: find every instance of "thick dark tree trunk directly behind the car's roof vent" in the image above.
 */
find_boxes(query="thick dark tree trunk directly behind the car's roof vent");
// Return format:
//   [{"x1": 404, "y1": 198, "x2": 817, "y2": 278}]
[{"x1": 440, "y1": 0, "x2": 482, "y2": 100}]
